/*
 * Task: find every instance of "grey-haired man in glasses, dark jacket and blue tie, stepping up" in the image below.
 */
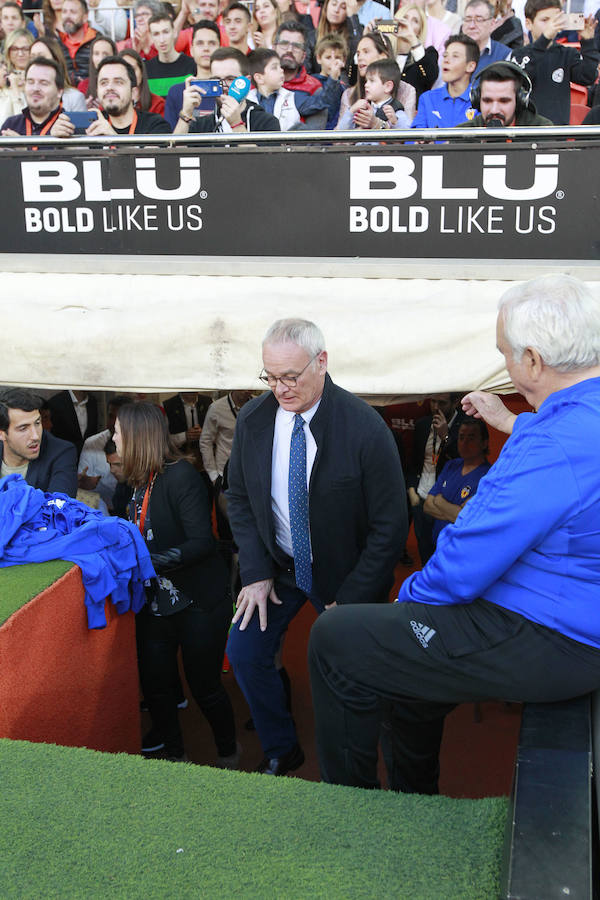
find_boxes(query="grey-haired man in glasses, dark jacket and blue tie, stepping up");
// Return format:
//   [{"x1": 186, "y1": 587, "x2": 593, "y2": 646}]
[{"x1": 227, "y1": 319, "x2": 407, "y2": 775}]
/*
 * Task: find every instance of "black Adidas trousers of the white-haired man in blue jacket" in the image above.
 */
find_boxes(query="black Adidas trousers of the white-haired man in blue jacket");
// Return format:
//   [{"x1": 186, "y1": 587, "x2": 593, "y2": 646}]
[{"x1": 309, "y1": 600, "x2": 600, "y2": 794}]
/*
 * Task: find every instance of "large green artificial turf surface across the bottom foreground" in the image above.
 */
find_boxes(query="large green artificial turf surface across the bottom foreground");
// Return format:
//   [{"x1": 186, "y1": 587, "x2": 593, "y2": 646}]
[{"x1": 0, "y1": 740, "x2": 507, "y2": 900}]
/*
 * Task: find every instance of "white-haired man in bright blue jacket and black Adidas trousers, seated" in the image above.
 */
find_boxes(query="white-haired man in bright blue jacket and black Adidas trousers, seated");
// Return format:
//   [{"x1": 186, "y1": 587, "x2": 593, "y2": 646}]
[{"x1": 309, "y1": 276, "x2": 600, "y2": 794}]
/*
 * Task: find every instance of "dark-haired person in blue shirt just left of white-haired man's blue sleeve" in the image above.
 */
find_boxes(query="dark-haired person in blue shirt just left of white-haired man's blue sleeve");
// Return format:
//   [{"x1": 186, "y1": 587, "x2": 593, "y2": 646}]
[{"x1": 423, "y1": 419, "x2": 491, "y2": 546}]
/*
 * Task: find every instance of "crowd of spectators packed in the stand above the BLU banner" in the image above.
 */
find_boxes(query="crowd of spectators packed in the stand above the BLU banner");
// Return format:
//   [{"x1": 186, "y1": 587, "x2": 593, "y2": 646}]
[{"x1": 0, "y1": 0, "x2": 600, "y2": 139}]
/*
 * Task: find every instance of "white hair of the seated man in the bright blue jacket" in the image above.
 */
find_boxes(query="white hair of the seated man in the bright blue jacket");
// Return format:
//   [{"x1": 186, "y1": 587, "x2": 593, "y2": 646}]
[{"x1": 498, "y1": 275, "x2": 600, "y2": 372}]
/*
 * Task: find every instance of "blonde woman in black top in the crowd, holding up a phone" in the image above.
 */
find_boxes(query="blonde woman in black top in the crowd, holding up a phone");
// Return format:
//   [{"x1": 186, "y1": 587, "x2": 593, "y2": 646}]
[{"x1": 396, "y1": 3, "x2": 439, "y2": 103}]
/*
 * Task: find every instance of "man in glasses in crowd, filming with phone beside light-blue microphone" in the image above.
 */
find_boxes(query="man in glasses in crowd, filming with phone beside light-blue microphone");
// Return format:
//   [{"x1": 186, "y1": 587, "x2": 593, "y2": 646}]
[{"x1": 173, "y1": 47, "x2": 280, "y2": 134}]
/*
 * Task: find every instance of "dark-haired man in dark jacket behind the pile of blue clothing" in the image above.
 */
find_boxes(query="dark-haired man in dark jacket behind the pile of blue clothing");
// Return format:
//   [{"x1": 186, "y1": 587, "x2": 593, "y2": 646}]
[{"x1": 0, "y1": 388, "x2": 77, "y2": 497}]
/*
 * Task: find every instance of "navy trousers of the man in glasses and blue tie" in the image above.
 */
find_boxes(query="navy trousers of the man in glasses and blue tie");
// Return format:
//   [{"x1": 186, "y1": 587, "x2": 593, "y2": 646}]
[{"x1": 227, "y1": 580, "x2": 323, "y2": 759}]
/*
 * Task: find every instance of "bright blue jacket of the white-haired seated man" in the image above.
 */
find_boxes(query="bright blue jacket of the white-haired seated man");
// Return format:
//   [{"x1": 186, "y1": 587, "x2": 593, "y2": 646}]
[{"x1": 398, "y1": 378, "x2": 600, "y2": 648}]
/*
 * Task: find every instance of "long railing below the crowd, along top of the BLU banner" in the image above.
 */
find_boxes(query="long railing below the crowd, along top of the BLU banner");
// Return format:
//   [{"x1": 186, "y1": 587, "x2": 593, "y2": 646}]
[{"x1": 0, "y1": 125, "x2": 600, "y2": 150}]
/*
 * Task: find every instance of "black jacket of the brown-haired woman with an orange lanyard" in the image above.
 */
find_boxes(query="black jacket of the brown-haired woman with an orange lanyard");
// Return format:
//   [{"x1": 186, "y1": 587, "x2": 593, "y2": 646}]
[{"x1": 148, "y1": 459, "x2": 229, "y2": 609}]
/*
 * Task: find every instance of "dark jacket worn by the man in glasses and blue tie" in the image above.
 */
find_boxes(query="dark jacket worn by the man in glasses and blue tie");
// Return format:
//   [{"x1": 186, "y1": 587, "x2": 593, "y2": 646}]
[{"x1": 227, "y1": 375, "x2": 407, "y2": 604}]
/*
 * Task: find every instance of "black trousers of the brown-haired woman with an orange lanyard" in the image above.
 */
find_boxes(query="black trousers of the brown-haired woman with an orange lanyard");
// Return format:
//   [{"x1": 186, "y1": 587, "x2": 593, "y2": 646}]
[{"x1": 136, "y1": 599, "x2": 236, "y2": 756}]
